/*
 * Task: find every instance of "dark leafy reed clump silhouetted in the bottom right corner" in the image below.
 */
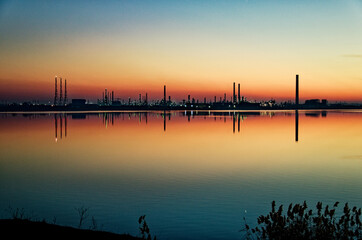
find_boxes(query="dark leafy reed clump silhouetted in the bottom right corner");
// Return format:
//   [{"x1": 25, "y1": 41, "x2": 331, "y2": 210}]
[{"x1": 242, "y1": 201, "x2": 362, "y2": 239}]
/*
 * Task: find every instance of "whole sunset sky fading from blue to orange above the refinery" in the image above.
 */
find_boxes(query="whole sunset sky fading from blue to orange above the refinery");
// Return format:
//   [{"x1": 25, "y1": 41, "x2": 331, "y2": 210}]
[{"x1": 0, "y1": 0, "x2": 362, "y2": 102}]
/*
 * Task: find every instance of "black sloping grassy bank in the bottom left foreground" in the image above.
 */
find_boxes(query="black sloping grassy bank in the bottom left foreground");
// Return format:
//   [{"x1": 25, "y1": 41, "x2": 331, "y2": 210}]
[{"x1": 0, "y1": 219, "x2": 141, "y2": 240}]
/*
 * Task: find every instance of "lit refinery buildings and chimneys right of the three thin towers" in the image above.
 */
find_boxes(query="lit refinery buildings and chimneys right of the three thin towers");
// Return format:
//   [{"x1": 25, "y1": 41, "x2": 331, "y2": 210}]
[{"x1": 59, "y1": 75, "x2": 328, "y2": 110}]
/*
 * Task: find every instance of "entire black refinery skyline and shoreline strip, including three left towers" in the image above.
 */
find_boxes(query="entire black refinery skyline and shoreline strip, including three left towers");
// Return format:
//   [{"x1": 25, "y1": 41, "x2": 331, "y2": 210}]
[{"x1": 0, "y1": 75, "x2": 362, "y2": 112}]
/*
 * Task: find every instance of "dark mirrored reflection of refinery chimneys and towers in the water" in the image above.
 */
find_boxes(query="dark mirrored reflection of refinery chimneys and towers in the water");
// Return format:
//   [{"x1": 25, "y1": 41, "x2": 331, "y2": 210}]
[{"x1": 48, "y1": 110, "x2": 308, "y2": 142}]
